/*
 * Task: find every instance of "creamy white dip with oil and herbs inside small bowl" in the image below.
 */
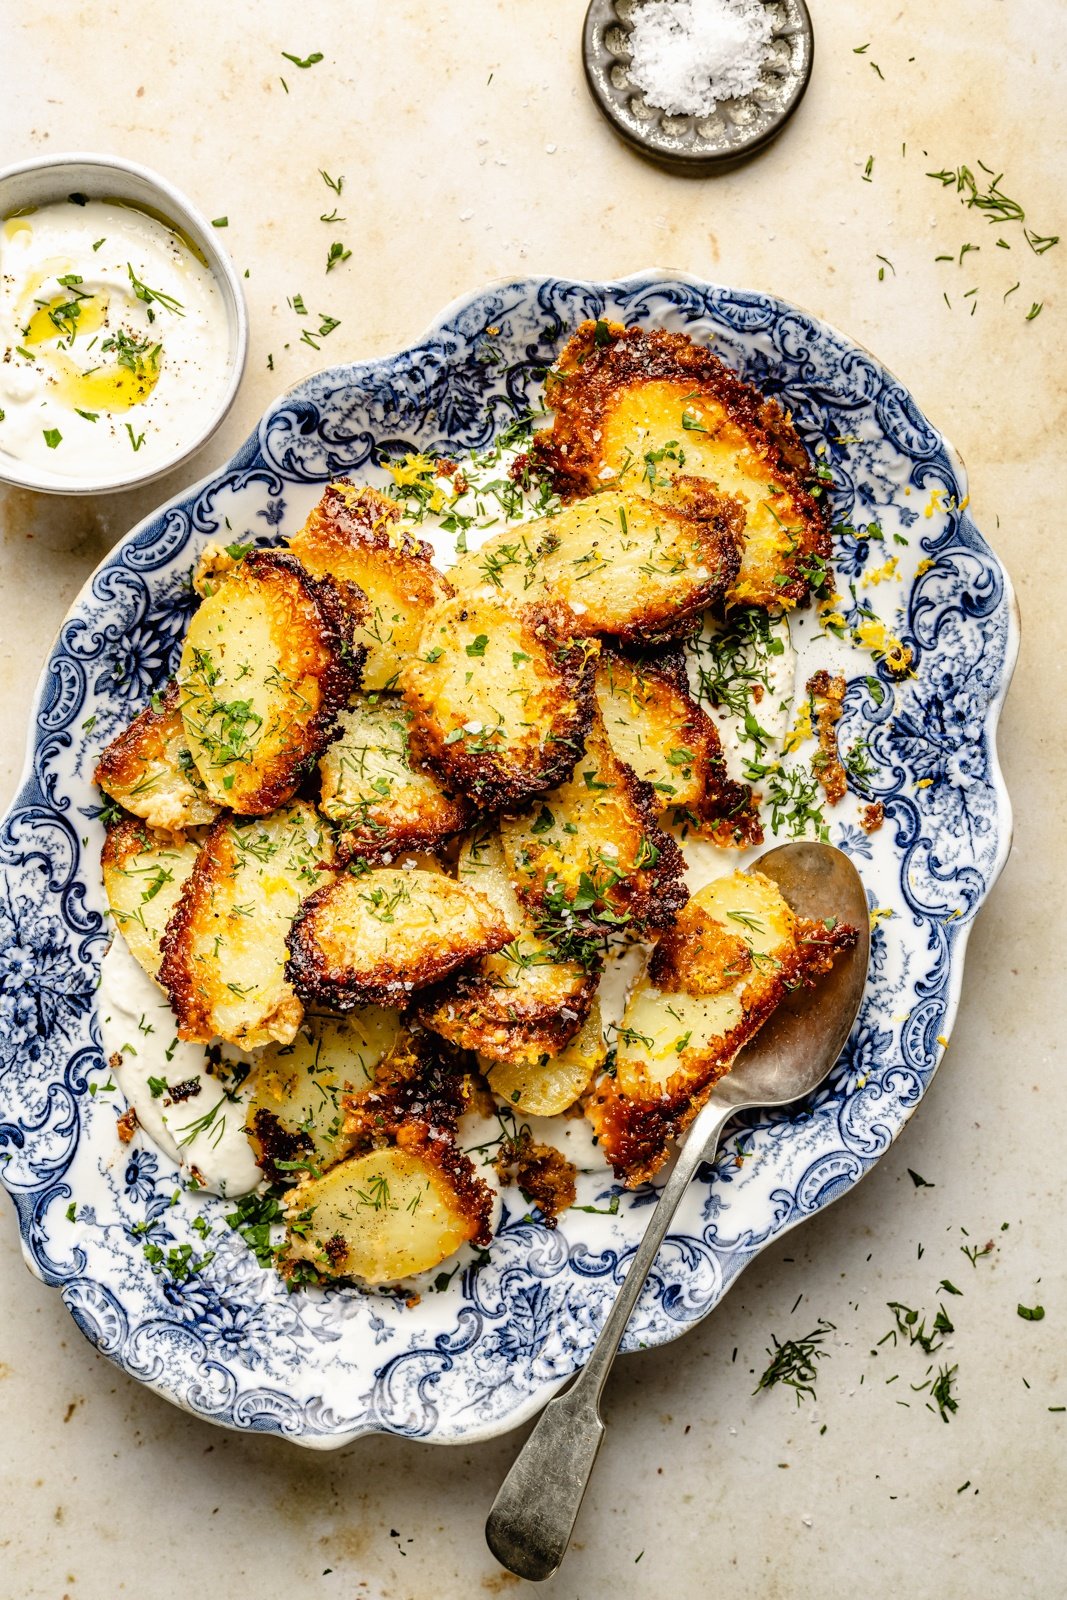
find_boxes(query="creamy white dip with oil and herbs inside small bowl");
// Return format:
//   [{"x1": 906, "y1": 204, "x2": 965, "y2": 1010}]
[{"x1": 0, "y1": 195, "x2": 229, "y2": 485}]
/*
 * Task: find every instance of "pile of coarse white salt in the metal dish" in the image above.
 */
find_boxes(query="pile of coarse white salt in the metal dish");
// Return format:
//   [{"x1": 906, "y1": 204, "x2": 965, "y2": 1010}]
[{"x1": 627, "y1": 0, "x2": 773, "y2": 117}]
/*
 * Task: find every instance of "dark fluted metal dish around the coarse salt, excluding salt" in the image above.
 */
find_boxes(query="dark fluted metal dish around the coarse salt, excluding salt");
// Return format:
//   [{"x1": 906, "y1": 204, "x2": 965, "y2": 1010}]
[{"x1": 582, "y1": 0, "x2": 814, "y2": 178}]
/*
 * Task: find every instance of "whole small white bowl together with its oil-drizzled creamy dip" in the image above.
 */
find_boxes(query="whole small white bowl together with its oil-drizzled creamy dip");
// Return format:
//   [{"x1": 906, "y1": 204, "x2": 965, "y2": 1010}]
[{"x1": 0, "y1": 155, "x2": 248, "y2": 494}]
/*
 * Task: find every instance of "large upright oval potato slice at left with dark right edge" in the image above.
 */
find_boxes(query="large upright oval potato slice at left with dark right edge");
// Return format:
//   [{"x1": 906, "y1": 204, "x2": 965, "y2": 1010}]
[{"x1": 178, "y1": 550, "x2": 362, "y2": 816}]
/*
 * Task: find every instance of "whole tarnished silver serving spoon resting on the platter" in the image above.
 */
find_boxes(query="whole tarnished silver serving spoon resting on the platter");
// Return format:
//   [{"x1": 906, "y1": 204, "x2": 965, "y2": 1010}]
[{"x1": 485, "y1": 842, "x2": 870, "y2": 1582}]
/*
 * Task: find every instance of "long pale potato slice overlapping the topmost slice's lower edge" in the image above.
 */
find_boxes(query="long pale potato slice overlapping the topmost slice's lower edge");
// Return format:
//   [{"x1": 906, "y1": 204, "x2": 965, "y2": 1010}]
[{"x1": 450, "y1": 478, "x2": 742, "y2": 645}]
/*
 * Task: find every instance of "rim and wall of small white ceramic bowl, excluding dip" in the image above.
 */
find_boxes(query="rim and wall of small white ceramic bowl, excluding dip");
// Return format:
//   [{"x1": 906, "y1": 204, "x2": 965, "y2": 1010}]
[{"x1": 0, "y1": 154, "x2": 248, "y2": 494}]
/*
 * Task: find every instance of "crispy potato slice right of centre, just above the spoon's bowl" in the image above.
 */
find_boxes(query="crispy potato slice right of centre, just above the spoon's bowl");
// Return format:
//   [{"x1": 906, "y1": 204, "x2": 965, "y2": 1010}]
[{"x1": 597, "y1": 651, "x2": 763, "y2": 845}]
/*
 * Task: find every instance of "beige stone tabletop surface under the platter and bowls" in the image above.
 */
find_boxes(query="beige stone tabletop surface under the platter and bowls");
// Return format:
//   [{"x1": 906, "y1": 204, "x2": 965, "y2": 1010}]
[{"x1": 0, "y1": 0, "x2": 1067, "y2": 1600}]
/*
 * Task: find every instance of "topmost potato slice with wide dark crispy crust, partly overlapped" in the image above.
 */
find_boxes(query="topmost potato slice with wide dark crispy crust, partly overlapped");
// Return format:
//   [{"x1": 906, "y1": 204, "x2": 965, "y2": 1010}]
[{"x1": 533, "y1": 322, "x2": 830, "y2": 608}]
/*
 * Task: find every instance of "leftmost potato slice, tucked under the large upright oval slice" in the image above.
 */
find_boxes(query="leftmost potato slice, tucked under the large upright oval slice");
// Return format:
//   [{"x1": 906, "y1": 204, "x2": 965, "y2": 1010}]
[{"x1": 93, "y1": 678, "x2": 219, "y2": 832}]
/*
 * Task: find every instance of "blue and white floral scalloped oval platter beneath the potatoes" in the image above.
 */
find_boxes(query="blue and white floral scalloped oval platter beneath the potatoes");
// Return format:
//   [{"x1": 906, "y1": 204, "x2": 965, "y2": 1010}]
[{"x1": 0, "y1": 272, "x2": 1017, "y2": 1448}]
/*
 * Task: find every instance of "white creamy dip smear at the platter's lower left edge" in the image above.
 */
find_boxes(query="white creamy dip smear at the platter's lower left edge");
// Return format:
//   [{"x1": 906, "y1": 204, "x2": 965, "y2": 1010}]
[{"x1": 99, "y1": 933, "x2": 262, "y2": 1197}]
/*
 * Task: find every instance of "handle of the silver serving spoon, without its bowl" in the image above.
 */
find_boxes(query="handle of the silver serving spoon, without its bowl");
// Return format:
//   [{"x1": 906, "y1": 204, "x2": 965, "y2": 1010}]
[{"x1": 485, "y1": 1101, "x2": 736, "y2": 1582}]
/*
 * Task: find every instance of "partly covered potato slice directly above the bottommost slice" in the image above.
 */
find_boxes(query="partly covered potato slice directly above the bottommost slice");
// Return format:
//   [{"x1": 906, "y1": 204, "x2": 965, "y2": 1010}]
[{"x1": 246, "y1": 1006, "x2": 400, "y2": 1182}]
